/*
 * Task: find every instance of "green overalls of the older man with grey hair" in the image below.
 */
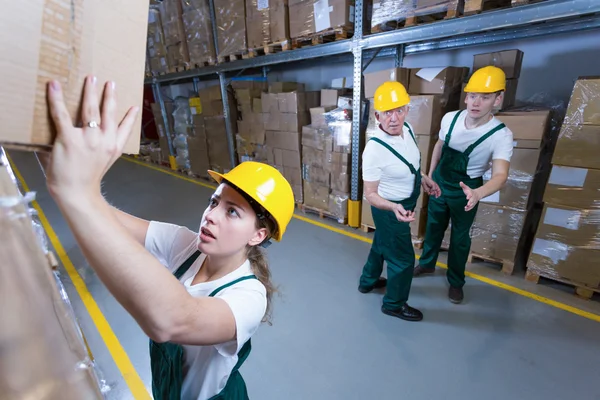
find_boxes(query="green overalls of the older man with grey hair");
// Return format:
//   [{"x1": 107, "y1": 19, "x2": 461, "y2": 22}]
[{"x1": 360, "y1": 123, "x2": 421, "y2": 311}]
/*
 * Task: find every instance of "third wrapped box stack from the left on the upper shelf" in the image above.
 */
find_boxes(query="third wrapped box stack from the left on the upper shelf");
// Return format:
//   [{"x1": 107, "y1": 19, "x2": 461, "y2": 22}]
[{"x1": 182, "y1": 0, "x2": 217, "y2": 66}]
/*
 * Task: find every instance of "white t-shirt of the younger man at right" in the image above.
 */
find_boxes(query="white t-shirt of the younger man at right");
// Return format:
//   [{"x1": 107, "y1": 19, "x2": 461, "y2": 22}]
[{"x1": 440, "y1": 110, "x2": 513, "y2": 178}]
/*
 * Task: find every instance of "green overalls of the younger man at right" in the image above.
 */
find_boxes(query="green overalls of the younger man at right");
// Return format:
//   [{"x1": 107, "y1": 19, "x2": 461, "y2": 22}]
[{"x1": 419, "y1": 110, "x2": 505, "y2": 288}]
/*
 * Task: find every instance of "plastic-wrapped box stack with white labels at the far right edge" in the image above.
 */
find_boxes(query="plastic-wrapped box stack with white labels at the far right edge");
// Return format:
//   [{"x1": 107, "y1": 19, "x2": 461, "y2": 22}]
[{"x1": 527, "y1": 78, "x2": 600, "y2": 291}]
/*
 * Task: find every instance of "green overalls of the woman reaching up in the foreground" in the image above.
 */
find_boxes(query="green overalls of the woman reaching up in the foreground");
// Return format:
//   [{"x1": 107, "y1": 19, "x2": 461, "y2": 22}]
[{"x1": 150, "y1": 251, "x2": 257, "y2": 400}]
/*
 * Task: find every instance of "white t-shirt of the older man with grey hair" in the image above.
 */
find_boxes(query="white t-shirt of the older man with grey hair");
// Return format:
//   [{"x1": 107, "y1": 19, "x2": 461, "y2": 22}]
[{"x1": 362, "y1": 126, "x2": 421, "y2": 201}]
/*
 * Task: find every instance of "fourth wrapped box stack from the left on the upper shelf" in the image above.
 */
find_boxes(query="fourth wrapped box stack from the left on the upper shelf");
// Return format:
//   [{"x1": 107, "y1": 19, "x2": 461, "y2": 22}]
[{"x1": 214, "y1": 0, "x2": 248, "y2": 57}]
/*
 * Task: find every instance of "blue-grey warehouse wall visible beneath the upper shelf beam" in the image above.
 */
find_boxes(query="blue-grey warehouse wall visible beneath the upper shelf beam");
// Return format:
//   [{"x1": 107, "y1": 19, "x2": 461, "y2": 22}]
[{"x1": 269, "y1": 30, "x2": 600, "y2": 107}]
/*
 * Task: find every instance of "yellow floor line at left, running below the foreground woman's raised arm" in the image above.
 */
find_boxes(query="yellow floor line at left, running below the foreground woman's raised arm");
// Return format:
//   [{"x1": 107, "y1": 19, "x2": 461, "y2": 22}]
[{"x1": 9, "y1": 157, "x2": 152, "y2": 400}]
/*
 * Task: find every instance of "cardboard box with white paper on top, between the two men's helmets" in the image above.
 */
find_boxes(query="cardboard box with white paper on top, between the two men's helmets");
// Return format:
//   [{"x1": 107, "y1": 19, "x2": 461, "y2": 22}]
[{"x1": 408, "y1": 67, "x2": 464, "y2": 94}]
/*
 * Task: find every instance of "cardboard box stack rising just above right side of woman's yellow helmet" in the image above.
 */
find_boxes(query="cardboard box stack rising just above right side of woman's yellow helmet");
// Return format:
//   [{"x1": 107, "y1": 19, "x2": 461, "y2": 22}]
[{"x1": 261, "y1": 82, "x2": 319, "y2": 203}]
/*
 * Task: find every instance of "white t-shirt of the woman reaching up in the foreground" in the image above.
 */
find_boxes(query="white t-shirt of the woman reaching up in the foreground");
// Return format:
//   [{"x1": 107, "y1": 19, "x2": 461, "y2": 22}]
[{"x1": 145, "y1": 221, "x2": 267, "y2": 400}]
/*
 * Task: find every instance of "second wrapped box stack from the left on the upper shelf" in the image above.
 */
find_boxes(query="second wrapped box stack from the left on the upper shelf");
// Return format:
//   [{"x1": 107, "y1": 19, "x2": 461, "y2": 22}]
[{"x1": 159, "y1": 0, "x2": 190, "y2": 72}]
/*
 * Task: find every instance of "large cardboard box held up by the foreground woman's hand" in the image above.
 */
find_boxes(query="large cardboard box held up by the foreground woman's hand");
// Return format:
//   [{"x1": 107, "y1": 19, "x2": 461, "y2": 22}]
[{"x1": 0, "y1": 0, "x2": 148, "y2": 154}]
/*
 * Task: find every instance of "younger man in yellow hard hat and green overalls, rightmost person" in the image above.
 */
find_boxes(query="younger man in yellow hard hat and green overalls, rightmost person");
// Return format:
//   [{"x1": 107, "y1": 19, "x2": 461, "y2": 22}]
[{"x1": 414, "y1": 66, "x2": 513, "y2": 303}]
